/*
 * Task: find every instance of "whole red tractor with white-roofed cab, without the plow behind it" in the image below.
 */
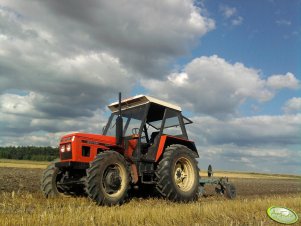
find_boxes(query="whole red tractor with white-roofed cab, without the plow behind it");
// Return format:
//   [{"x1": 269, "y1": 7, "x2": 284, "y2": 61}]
[{"x1": 41, "y1": 94, "x2": 199, "y2": 206}]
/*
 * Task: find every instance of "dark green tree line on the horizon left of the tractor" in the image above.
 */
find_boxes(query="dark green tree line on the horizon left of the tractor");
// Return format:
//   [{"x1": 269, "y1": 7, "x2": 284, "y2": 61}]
[{"x1": 0, "y1": 146, "x2": 59, "y2": 161}]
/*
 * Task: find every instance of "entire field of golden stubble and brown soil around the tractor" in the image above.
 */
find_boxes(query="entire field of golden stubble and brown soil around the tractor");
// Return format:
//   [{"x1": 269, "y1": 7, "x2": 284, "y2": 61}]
[{"x1": 0, "y1": 160, "x2": 301, "y2": 225}]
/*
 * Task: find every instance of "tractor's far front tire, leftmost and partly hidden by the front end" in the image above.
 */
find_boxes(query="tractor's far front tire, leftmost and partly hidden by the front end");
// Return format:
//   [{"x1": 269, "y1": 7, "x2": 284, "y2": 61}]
[{"x1": 41, "y1": 162, "x2": 63, "y2": 198}]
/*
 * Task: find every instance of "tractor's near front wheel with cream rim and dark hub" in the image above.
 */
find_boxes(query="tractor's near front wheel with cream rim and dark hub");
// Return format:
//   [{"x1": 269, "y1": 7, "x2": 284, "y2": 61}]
[{"x1": 86, "y1": 151, "x2": 131, "y2": 206}]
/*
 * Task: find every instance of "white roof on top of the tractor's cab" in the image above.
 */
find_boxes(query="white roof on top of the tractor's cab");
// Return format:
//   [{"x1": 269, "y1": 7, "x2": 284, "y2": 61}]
[{"x1": 108, "y1": 95, "x2": 182, "y2": 112}]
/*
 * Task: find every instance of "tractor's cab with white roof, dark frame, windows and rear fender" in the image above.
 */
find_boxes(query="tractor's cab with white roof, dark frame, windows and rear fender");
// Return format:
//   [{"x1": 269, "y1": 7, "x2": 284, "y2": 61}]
[{"x1": 103, "y1": 95, "x2": 197, "y2": 162}]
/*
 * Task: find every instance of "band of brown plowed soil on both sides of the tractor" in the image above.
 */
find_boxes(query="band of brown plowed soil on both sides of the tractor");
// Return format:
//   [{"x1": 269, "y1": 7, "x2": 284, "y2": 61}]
[{"x1": 0, "y1": 167, "x2": 301, "y2": 197}]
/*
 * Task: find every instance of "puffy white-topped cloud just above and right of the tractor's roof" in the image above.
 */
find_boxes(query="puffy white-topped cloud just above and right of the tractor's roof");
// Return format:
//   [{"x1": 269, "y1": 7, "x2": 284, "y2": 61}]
[{"x1": 142, "y1": 55, "x2": 299, "y2": 116}]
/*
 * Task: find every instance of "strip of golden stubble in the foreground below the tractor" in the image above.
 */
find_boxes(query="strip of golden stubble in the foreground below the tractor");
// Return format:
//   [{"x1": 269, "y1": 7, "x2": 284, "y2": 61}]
[{"x1": 0, "y1": 192, "x2": 301, "y2": 226}]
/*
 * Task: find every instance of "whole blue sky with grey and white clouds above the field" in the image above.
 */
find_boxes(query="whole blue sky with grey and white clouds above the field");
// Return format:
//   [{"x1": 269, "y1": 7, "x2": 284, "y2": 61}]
[{"x1": 0, "y1": 0, "x2": 301, "y2": 174}]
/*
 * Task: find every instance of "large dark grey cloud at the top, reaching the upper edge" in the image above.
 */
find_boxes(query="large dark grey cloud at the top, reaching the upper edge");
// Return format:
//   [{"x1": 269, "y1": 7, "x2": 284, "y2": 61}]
[{"x1": 1, "y1": 0, "x2": 215, "y2": 76}]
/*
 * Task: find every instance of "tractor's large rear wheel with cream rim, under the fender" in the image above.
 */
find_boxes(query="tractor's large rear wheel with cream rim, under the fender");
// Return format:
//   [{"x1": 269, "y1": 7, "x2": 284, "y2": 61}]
[{"x1": 156, "y1": 144, "x2": 199, "y2": 202}]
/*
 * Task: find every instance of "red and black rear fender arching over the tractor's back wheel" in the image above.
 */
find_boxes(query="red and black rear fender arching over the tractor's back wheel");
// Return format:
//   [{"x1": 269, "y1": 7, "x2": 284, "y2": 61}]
[{"x1": 155, "y1": 135, "x2": 199, "y2": 162}]
